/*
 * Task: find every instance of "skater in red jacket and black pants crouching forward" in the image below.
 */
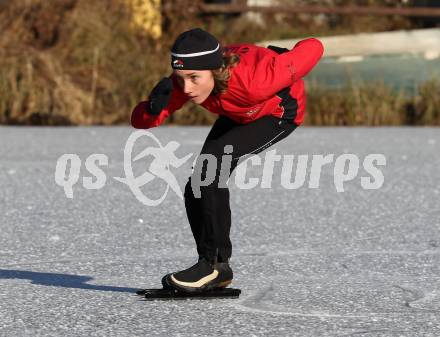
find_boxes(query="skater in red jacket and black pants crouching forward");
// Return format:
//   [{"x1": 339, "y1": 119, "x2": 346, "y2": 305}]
[{"x1": 131, "y1": 28, "x2": 323, "y2": 292}]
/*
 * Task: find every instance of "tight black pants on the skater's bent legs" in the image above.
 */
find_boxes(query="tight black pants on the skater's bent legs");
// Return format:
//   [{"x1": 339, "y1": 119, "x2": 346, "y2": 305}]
[{"x1": 187, "y1": 116, "x2": 296, "y2": 259}]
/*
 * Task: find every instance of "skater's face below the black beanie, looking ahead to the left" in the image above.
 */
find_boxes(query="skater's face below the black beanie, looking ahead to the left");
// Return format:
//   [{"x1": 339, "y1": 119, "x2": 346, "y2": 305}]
[{"x1": 174, "y1": 70, "x2": 214, "y2": 104}]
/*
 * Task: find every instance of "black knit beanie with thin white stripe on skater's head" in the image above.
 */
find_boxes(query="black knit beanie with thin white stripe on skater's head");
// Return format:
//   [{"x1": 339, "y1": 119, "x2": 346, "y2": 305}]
[{"x1": 171, "y1": 28, "x2": 223, "y2": 70}]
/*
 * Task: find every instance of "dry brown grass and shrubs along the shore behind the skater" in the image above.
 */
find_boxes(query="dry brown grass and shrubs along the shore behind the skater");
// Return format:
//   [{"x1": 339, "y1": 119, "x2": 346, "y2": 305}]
[{"x1": 0, "y1": 0, "x2": 440, "y2": 126}]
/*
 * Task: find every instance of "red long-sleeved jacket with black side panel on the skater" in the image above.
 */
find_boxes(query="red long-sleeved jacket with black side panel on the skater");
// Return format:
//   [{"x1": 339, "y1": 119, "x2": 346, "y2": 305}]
[{"x1": 131, "y1": 38, "x2": 324, "y2": 129}]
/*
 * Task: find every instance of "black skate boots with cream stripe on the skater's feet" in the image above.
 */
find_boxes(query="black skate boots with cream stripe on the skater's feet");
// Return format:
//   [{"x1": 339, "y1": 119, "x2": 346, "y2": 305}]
[{"x1": 167, "y1": 257, "x2": 233, "y2": 292}]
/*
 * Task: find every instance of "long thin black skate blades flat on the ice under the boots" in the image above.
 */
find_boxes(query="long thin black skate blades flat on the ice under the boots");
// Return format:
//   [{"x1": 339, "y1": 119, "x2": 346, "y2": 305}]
[{"x1": 138, "y1": 288, "x2": 241, "y2": 301}]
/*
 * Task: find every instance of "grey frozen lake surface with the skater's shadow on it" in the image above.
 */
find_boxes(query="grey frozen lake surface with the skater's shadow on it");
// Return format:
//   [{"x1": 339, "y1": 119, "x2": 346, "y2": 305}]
[{"x1": 0, "y1": 127, "x2": 440, "y2": 337}]
